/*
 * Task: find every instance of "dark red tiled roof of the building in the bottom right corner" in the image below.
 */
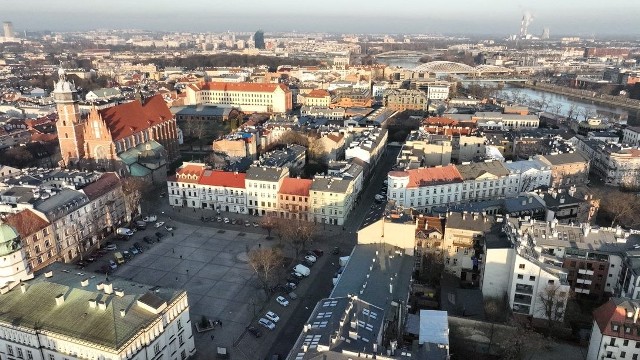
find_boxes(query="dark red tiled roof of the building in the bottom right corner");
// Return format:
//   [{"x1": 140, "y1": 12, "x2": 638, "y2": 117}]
[{"x1": 593, "y1": 298, "x2": 640, "y2": 341}]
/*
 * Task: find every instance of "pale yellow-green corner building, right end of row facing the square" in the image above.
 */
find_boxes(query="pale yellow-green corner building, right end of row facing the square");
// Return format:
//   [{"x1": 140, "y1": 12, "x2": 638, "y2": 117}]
[{"x1": 310, "y1": 176, "x2": 357, "y2": 225}]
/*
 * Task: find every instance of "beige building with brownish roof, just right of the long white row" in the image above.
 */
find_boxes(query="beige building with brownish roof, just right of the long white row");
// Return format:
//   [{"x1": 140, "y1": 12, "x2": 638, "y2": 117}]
[{"x1": 534, "y1": 152, "x2": 590, "y2": 188}]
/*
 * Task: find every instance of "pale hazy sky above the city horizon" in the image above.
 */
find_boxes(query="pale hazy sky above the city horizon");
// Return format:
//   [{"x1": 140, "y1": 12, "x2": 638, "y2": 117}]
[{"x1": 5, "y1": 0, "x2": 640, "y2": 36}]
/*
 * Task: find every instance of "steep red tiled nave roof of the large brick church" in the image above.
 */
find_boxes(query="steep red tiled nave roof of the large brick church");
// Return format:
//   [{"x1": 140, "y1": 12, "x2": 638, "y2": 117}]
[{"x1": 98, "y1": 95, "x2": 173, "y2": 141}]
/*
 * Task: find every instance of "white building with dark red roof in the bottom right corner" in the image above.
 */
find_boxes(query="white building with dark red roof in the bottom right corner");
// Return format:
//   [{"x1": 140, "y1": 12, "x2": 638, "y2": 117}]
[{"x1": 587, "y1": 298, "x2": 640, "y2": 360}]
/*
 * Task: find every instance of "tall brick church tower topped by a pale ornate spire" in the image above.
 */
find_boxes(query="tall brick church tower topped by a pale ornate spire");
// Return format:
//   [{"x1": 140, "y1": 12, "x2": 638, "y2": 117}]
[{"x1": 53, "y1": 68, "x2": 84, "y2": 167}]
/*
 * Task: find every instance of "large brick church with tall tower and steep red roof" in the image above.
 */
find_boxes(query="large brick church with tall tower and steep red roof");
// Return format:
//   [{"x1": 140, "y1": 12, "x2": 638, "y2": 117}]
[{"x1": 53, "y1": 69, "x2": 180, "y2": 181}]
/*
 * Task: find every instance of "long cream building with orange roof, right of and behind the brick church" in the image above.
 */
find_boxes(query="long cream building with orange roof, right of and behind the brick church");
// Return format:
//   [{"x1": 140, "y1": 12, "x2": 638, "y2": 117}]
[{"x1": 185, "y1": 82, "x2": 293, "y2": 113}]
